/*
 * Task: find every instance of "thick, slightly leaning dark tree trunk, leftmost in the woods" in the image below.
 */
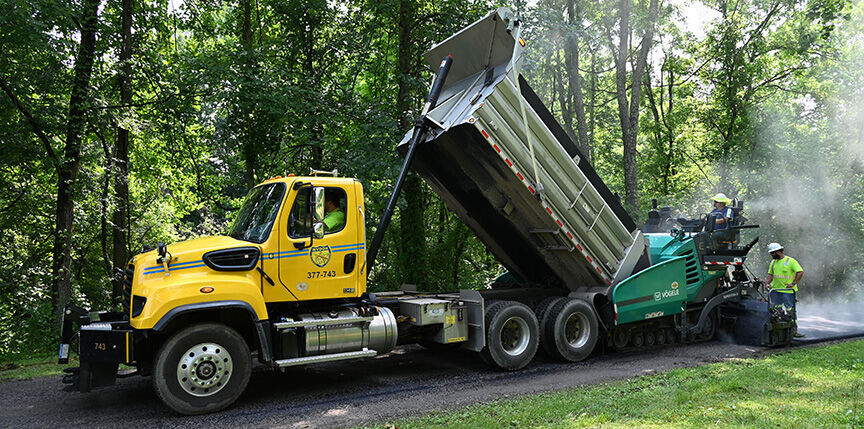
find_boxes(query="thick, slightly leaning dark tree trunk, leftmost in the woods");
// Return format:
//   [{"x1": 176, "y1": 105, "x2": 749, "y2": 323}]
[{"x1": 51, "y1": 0, "x2": 100, "y2": 323}]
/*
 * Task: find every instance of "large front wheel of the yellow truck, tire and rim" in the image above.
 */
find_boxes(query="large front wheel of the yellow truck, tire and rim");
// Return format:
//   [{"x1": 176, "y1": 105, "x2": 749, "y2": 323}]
[{"x1": 153, "y1": 323, "x2": 252, "y2": 415}]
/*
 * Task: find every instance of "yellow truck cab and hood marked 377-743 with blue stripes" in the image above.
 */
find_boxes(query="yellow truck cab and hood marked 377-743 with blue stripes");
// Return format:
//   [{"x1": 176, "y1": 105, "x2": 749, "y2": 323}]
[{"x1": 125, "y1": 176, "x2": 366, "y2": 329}]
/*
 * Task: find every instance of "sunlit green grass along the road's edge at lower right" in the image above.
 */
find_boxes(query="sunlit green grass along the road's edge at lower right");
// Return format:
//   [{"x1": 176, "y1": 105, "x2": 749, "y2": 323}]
[{"x1": 379, "y1": 341, "x2": 864, "y2": 429}]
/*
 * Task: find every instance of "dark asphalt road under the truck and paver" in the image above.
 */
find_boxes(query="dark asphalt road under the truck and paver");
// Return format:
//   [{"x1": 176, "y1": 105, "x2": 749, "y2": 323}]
[{"x1": 0, "y1": 310, "x2": 864, "y2": 428}]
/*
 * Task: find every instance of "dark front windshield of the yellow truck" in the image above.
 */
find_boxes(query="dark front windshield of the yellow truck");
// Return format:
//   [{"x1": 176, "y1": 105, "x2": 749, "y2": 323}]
[{"x1": 228, "y1": 183, "x2": 285, "y2": 243}]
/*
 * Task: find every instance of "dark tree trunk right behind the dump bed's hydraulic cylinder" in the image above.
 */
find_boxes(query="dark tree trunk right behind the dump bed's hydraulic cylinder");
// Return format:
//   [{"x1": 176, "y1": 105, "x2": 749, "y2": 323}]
[{"x1": 396, "y1": 0, "x2": 426, "y2": 285}]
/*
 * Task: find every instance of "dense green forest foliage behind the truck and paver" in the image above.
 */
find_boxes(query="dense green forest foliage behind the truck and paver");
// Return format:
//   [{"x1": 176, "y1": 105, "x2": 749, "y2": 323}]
[{"x1": 0, "y1": 0, "x2": 864, "y2": 357}]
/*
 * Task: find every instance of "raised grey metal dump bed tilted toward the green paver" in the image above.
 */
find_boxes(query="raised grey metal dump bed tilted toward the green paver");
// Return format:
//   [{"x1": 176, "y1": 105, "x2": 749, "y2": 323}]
[{"x1": 399, "y1": 8, "x2": 648, "y2": 291}]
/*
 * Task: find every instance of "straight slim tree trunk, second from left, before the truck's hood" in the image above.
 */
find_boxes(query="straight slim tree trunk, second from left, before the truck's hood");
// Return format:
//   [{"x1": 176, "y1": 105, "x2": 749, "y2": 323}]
[{"x1": 111, "y1": 0, "x2": 133, "y2": 300}]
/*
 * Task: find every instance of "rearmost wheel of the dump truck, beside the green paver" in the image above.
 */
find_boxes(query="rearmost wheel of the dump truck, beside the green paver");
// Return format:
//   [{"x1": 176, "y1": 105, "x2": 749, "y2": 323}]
[{"x1": 541, "y1": 299, "x2": 598, "y2": 362}]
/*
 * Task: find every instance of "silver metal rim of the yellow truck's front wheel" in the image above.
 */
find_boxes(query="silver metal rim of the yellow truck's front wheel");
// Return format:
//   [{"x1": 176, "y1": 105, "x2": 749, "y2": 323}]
[{"x1": 177, "y1": 343, "x2": 234, "y2": 397}]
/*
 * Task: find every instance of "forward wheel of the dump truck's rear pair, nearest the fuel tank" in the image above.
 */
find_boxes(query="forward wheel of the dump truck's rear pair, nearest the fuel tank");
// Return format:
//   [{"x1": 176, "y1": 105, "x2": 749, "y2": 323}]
[{"x1": 480, "y1": 301, "x2": 539, "y2": 371}]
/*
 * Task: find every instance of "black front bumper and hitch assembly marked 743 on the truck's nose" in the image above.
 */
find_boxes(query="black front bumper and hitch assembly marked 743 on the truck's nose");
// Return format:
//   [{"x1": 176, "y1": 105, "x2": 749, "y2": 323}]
[{"x1": 57, "y1": 305, "x2": 135, "y2": 392}]
